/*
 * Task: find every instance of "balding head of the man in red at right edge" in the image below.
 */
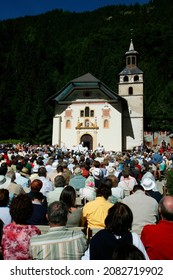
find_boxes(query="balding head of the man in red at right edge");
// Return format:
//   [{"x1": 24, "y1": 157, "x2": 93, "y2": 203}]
[{"x1": 159, "y1": 195, "x2": 173, "y2": 221}]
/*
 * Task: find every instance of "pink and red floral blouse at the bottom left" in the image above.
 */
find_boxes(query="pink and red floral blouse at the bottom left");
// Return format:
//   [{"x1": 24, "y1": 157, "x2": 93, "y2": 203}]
[{"x1": 1, "y1": 223, "x2": 41, "y2": 260}]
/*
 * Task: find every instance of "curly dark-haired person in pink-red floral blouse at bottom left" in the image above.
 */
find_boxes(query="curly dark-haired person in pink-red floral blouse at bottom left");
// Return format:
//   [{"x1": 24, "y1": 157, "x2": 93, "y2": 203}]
[{"x1": 2, "y1": 194, "x2": 41, "y2": 260}]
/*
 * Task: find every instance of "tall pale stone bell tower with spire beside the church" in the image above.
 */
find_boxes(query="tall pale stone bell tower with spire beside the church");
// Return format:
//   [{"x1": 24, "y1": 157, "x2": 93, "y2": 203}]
[{"x1": 118, "y1": 39, "x2": 144, "y2": 150}]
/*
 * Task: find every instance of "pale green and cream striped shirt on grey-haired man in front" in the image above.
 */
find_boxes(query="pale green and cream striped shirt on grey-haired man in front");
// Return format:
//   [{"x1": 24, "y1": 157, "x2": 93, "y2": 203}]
[{"x1": 30, "y1": 227, "x2": 87, "y2": 260}]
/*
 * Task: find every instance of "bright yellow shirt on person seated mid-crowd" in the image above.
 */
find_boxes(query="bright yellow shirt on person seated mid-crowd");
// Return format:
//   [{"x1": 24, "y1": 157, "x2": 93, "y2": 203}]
[{"x1": 83, "y1": 196, "x2": 113, "y2": 228}]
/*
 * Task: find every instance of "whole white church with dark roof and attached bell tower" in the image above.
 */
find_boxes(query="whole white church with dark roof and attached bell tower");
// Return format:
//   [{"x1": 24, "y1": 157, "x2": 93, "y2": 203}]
[{"x1": 49, "y1": 39, "x2": 144, "y2": 152}]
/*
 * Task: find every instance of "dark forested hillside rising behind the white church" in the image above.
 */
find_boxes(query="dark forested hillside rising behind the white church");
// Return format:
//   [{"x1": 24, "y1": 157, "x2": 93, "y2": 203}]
[{"x1": 0, "y1": 0, "x2": 173, "y2": 143}]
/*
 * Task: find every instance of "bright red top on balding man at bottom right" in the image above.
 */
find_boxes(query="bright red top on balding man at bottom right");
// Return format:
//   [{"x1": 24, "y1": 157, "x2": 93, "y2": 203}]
[{"x1": 141, "y1": 220, "x2": 173, "y2": 260}]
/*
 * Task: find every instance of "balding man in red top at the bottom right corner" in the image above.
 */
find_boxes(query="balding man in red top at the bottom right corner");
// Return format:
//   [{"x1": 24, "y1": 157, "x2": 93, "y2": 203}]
[{"x1": 141, "y1": 196, "x2": 173, "y2": 260}]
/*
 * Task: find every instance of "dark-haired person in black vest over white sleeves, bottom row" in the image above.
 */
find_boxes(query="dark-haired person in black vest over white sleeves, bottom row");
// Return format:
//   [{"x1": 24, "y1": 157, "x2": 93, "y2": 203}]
[{"x1": 89, "y1": 202, "x2": 148, "y2": 260}]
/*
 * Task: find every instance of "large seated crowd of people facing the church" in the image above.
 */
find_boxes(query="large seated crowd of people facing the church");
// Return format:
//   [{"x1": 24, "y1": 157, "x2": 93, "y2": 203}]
[{"x1": 0, "y1": 143, "x2": 173, "y2": 260}]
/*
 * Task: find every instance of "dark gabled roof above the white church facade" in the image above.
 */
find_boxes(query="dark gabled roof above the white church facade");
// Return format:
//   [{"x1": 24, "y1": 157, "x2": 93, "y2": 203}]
[{"x1": 47, "y1": 73, "x2": 122, "y2": 103}]
